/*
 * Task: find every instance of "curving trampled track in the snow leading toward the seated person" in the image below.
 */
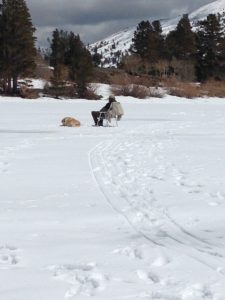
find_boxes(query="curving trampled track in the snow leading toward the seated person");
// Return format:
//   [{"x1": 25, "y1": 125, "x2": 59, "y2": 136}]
[{"x1": 89, "y1": 127, "x2": 225, "y2": 275}]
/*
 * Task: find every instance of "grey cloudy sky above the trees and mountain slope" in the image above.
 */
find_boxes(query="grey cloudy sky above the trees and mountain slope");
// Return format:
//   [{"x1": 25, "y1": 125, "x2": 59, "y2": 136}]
[{"x1": 27, "y1": 0, "x2": 213, "y2": 46}]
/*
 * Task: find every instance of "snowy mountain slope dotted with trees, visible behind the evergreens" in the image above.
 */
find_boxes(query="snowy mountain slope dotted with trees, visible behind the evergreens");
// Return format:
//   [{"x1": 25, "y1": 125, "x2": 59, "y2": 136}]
[{"x1": 89, "y1": 0, "x2": 225, "y2": 67}]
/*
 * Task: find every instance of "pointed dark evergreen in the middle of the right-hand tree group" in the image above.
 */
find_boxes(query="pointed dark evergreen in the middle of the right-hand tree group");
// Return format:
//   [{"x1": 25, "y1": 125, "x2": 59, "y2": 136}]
[{"x1": 166, "y1": 14, "x2": 197, "y2": 60}]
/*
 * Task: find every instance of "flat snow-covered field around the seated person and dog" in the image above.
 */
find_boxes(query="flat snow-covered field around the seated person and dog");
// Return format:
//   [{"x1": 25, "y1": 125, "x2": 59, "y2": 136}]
[{"x1": 0, "y1": 96, "x2": 225, "y2": 300}]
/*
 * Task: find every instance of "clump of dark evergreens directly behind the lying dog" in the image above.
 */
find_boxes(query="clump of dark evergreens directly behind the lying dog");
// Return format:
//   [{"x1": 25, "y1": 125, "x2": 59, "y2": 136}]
[{"x1": 49, "y1": 29, "x2": 93, "y2": 98}]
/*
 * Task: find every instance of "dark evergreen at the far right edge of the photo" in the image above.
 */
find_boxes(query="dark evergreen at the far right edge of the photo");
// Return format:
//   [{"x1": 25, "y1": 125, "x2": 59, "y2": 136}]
[{"x1": 197, "y1": 14, "x2": 225, "y2": 80}]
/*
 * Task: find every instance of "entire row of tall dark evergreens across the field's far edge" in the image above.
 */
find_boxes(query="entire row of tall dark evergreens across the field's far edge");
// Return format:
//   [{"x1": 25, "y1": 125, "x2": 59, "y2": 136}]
[{"x1": 0, "y1": 0, "x2": 225, "y2": 97}]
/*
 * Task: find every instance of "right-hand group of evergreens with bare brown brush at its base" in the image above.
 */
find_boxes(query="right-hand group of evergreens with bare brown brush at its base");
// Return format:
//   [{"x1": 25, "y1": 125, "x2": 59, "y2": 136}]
[{"x1": 123, "y1": 14, "x2": 225, "y2": 81}]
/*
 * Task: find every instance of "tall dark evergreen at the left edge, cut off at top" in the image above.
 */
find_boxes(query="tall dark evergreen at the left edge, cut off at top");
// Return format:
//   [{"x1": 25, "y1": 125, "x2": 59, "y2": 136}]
[{"x1": 0, "y1": 0, "x2": 36, "y2": 93}]
